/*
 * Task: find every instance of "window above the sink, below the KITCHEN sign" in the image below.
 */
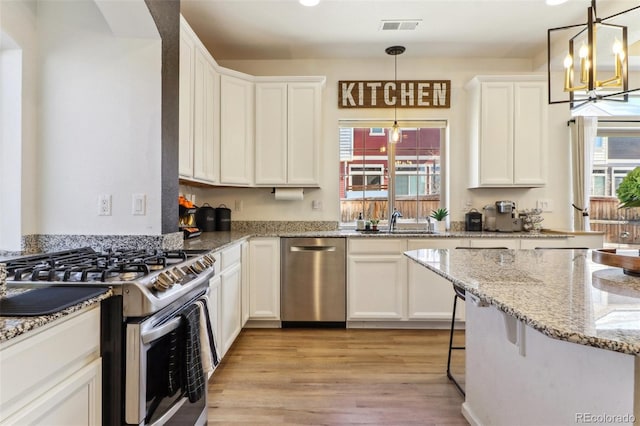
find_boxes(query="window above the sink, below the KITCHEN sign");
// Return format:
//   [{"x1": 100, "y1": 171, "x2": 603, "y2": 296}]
[{"x1": 339, "y1": 121, "x2": 446, "y2": 227}]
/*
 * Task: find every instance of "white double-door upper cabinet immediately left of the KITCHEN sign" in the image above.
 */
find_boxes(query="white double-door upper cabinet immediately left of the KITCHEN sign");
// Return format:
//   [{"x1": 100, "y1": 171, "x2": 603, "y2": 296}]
[{"x1": 255, "y1": 78, "x2": 324, "y2": 186}]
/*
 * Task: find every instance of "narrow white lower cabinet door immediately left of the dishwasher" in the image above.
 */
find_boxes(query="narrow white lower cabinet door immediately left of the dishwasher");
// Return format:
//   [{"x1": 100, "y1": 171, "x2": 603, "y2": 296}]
[{"x1": 249, "y1": 238, "x2": 280, "y2": 320}]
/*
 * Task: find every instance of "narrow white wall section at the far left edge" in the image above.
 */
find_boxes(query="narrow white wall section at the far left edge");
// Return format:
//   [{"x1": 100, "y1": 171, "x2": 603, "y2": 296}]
[{"x1": 0, "y1": 1, "x2": 39, "y2": 250}]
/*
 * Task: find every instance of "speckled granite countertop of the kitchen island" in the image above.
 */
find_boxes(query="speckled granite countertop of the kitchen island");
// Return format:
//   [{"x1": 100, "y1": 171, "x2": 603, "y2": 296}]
[{"x1": 405, "y1": 249, "x2": 640, "y2": 355}]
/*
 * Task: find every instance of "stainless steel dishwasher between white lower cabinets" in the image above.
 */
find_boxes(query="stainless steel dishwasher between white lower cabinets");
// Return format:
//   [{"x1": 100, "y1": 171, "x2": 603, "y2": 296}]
[{"x1": 280, "y1": 238, "x2": 347, "y2": 327}]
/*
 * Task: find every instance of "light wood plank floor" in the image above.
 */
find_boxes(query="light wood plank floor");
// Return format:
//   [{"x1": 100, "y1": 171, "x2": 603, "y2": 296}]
[{"x1": 208, "y1": 329, "x2": 467, "y2": 425}]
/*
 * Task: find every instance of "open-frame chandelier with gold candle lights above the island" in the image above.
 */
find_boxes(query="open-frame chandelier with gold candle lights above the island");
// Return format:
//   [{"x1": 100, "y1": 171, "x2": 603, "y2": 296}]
[{"x1": 547, "y1": 0, "x2": 640, "y2": 109}]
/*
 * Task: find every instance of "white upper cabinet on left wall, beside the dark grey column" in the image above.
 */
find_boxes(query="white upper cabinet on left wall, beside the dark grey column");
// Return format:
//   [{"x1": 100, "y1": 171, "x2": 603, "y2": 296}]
[{"x1": 178, "y1": 19, "x2": 220, "y2": 183}]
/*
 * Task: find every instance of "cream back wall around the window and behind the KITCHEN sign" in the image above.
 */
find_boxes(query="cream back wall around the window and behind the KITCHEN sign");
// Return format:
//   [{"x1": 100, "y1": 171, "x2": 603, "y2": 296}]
[{"x1": 181, "y1": 58, "x2": 570, "y2": 228}]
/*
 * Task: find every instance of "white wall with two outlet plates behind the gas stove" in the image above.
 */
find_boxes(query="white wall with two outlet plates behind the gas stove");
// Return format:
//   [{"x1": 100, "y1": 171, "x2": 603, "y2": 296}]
[{"x1": 32, "y1": 0, "x2": 161, "y2": 235}]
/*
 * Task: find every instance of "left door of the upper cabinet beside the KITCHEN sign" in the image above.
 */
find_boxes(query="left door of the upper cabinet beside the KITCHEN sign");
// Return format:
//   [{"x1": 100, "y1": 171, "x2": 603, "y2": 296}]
[{"x1": 256, "y1": 83, "x2": 288, "y2": 185}]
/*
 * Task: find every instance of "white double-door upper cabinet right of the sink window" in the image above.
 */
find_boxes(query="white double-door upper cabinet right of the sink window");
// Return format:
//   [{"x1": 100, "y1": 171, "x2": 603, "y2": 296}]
[{"x1": 466, "y1": 75, "x2": 547, "y2": 188}]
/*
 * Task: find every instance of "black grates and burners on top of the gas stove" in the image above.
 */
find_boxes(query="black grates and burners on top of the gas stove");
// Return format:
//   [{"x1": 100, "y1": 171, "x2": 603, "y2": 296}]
[{"x1": 7, "y1": 247, "x2": 194, "y2": 282}]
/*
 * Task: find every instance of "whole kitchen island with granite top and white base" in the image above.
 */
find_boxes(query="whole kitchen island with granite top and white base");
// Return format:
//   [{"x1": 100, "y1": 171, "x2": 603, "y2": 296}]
[{"x1": 405, "y1": 249, "x2": 640, "y2": 425}]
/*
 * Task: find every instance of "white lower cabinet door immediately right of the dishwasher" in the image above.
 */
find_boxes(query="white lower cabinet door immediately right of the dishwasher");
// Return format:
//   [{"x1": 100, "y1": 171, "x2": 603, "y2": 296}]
[{"x1": 347, "y1": 253, "x2": 407, "y2": 320}]
